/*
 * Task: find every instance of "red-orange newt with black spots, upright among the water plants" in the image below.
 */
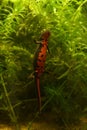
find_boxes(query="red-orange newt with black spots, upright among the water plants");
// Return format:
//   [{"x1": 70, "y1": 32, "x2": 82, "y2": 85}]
[{"x1": 34, "y1": 31, "x2": 50, "y2": 112}]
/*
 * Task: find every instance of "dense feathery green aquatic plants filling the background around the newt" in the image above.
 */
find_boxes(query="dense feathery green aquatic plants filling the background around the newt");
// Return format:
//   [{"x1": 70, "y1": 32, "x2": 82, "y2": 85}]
[{"x1": 0, "y1": 0, "x2": 87, "y2": 127}]
